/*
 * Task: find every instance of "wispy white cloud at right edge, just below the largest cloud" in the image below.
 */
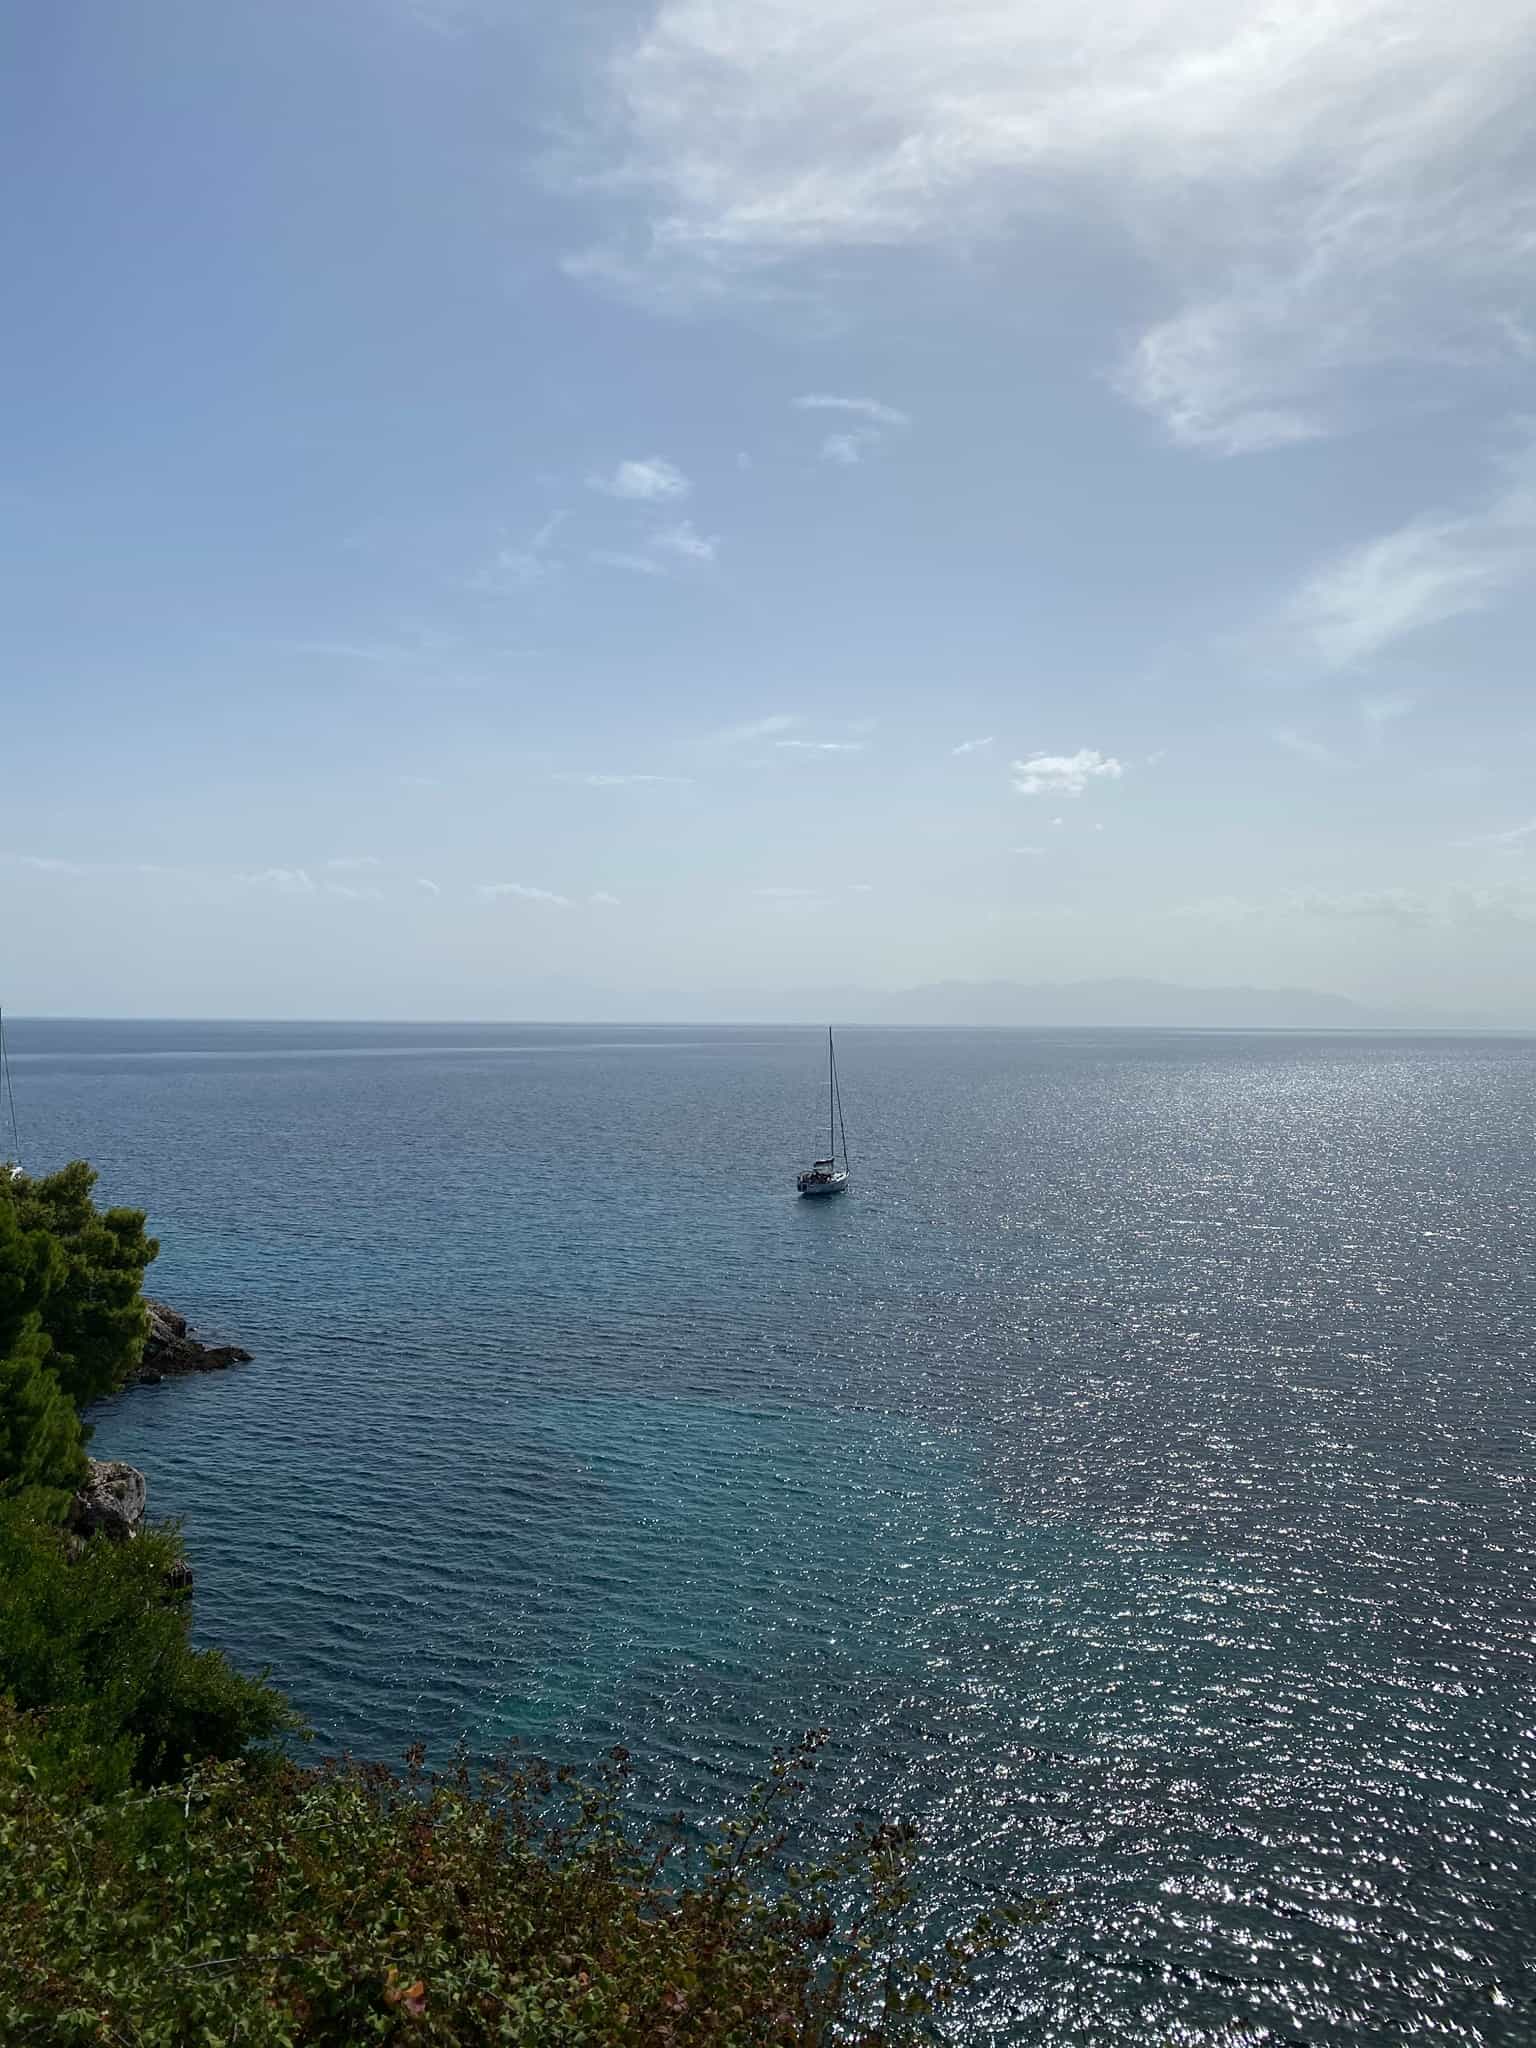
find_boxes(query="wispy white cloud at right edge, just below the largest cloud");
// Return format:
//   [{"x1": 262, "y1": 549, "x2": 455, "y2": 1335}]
[{"x1": 1280, "y1": 444, "x2": 1536, "y2": 670}]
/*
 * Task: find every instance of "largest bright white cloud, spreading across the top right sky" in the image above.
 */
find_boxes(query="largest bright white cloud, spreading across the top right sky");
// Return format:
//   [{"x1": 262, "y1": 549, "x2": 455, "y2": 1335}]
[{"x1": 563, "y1": 0, "x2": 1536, "y2": 455}]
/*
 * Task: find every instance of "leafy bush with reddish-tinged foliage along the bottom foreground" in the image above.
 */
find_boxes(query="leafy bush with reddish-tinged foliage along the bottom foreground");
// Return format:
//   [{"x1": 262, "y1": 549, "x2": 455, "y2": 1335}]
[{"x1": 0, "y1": 1710, "x2": 1024, "y2": 2048}]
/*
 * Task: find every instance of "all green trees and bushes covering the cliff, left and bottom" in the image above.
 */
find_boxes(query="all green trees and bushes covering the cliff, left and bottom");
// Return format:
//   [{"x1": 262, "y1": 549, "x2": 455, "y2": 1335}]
[{"x1": 0, "y1": 1165, "x2": 1016, "y2": 2048}]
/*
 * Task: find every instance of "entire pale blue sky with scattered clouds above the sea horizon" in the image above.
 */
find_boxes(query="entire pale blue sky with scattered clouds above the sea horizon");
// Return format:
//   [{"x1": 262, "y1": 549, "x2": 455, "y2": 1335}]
[{"x1": 0, "y1": 0, "x2": 1536, "y2": 1026}]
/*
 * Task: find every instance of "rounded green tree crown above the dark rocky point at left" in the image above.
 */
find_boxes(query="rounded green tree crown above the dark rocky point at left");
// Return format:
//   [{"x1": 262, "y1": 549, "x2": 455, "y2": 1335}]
[{"x1": 0, "y1": 1159, "x2": 160, "y2": 1407}]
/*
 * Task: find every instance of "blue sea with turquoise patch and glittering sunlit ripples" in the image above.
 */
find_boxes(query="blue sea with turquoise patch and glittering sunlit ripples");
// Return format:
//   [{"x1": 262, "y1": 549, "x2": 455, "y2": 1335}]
[{"x1": 12, "y1": 1024, "x2": 1536, "y2": 2048}]
